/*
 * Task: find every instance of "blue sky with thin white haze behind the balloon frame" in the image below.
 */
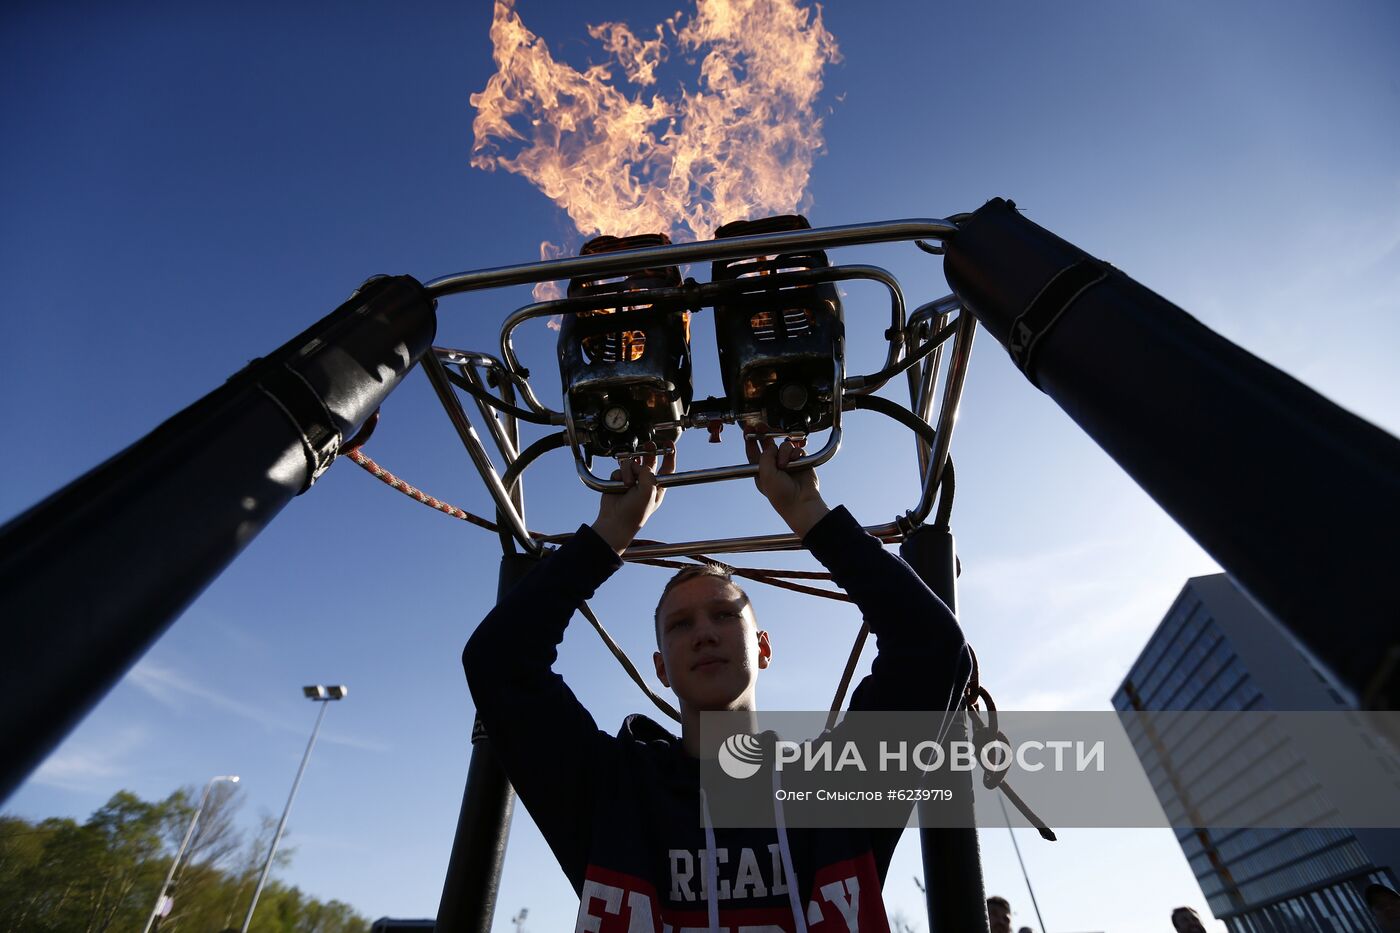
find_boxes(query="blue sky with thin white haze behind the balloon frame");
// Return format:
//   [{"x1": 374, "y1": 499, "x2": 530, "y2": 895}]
[{"x1": 0, "y1": 0, "x2": 1400, "y2": 932}]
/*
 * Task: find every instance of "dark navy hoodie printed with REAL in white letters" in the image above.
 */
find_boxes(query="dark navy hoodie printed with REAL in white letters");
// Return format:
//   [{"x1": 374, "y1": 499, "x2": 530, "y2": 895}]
[{"x1": 462, "y1": 507, "x2": 969, "y2": 933}]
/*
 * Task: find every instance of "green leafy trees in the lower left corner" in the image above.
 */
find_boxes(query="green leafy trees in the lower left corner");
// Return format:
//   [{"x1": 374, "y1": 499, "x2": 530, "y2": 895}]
[{"x1": 0, "y1": 785, "x2": 370, "y2": 933}]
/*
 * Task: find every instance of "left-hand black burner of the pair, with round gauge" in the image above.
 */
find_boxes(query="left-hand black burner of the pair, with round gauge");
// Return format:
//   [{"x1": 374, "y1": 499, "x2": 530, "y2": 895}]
[{"x1": 559, "y1": 234, "x2": 692, "y2": 457}]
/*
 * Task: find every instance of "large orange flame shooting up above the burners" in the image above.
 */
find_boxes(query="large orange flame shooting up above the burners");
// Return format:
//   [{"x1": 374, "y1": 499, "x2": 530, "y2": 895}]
[{"x1": 470, "y1": 0, "x2": 840, "y2": 257}]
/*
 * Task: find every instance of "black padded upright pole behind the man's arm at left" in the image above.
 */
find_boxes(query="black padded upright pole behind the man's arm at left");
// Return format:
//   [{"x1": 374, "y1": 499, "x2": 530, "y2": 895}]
[{"x1": 435, "y1": 553, "x2": 538, "y2": 933}]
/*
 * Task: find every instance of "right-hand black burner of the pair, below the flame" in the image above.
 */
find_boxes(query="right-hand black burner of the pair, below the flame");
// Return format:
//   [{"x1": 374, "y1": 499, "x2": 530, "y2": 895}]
[{"x1": 711, "y1": 214, "x2": 843, "y2": 441}]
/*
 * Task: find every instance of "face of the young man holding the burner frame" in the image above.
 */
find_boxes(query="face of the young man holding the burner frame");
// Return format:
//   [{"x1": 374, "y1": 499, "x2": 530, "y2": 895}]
[{"x1": 654, "y1": 577, "x2": 771, "y2": 710}]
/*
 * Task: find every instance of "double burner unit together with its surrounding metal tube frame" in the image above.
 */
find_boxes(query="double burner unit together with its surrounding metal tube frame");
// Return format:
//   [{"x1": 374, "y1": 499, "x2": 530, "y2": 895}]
[{"x1": 424, "y1": 208, "x2": 976, "y2": 556}]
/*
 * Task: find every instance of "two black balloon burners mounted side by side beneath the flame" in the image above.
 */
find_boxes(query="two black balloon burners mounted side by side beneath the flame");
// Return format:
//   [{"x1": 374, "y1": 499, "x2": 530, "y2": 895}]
[{"x1": 556, "y1": 214, "x2": 841, "y2": 457}]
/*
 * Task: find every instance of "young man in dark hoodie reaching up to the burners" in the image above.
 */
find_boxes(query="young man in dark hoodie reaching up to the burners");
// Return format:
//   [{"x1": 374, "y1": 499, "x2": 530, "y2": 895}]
[{"x1": 462, "y1": 438, "x2": 969, "y2": 933}]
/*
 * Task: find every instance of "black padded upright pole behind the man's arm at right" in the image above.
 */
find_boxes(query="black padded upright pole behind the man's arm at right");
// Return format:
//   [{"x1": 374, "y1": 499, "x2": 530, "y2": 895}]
[{"x1": 899, "y1": 525, "x2": 988, "y2": 933}]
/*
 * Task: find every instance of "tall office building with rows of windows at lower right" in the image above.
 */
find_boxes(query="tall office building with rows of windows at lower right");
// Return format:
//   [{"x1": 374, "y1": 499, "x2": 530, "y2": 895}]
[{"x1": 1113, "y1": 574, "x2": 1400, "y2": 933}]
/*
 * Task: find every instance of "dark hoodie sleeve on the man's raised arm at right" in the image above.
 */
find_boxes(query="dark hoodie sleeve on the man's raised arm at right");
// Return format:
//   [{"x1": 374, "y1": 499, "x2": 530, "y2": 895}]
[{"x1": 802, "y1": 506, "x2": 970, "y2": 710}]
